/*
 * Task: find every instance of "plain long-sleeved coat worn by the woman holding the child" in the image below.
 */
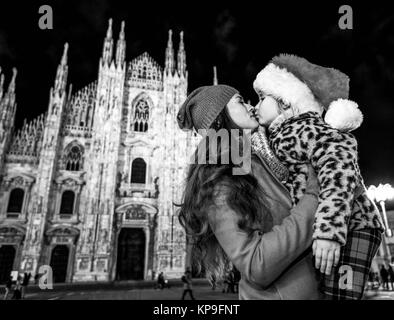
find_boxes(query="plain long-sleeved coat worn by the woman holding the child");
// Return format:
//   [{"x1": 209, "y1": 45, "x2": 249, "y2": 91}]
[{"x1": 208, "y1": 155, "x2": 321, "y2": 300}]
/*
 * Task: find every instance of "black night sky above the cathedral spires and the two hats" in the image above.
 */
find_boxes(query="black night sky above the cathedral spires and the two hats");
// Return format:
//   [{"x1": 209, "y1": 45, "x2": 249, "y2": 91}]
[{"x1": 0, "y1": 0, "x2": 394, "y2": 192}]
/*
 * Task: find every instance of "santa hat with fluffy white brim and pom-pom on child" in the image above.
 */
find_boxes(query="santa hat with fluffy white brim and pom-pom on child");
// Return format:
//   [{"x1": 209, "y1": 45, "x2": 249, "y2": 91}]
[{"x1": 253, "y1": 54, "x2": 363, "y2": 131}]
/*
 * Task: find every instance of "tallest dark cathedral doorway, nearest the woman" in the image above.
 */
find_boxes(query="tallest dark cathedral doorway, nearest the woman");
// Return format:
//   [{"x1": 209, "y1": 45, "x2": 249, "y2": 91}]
[{"x1": 116, "y1": 228, "x2": 145, "y2": 280}]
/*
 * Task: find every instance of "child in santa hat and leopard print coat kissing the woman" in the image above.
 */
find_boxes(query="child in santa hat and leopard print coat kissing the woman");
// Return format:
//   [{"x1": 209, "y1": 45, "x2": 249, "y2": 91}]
[{"x1": 252, "y1": 55, "x2": 384, "y2": 299}]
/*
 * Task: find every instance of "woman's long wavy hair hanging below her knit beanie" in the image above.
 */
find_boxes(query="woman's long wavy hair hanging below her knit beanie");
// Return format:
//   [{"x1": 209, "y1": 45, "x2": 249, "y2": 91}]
[{"x1": 179, "y1": 111, "x2": 269, "y2": 279}]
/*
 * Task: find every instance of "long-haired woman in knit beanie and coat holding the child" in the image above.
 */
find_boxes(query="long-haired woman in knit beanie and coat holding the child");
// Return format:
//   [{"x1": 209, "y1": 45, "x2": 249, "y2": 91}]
[{"x1": 178, "y1": 85, "x2": 321, "y2": 299}]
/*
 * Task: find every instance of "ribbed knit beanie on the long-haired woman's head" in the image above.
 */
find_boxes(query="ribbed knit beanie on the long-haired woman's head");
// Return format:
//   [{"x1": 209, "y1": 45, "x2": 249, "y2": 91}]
[{"x1": 177, "y1": 84, "x2": 239, "y2": 131}]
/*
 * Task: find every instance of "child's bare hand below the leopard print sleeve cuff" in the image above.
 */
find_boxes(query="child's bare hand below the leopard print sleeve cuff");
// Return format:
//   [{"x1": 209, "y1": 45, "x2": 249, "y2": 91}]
[{"x1": 312, "y1": 239, "x2": 341, "y2": 275}]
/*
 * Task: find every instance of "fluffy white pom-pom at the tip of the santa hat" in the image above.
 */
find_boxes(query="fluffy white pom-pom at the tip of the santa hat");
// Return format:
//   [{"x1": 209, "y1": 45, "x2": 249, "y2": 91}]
[{"x1": 324, "y1": 99, "x2": 363, "y2": 132}]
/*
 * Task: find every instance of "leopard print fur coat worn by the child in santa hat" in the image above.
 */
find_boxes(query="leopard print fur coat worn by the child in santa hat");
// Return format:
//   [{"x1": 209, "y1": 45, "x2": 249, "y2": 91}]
[{"x1": 269, "y1": 112, "x2": 384, "y2": 245}]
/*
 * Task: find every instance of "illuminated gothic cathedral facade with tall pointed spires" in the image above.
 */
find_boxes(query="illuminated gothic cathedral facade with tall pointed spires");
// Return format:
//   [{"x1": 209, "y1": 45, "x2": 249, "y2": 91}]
[{"x1": 0, "y1": 20, "x2": 198, "y2": 282}]
